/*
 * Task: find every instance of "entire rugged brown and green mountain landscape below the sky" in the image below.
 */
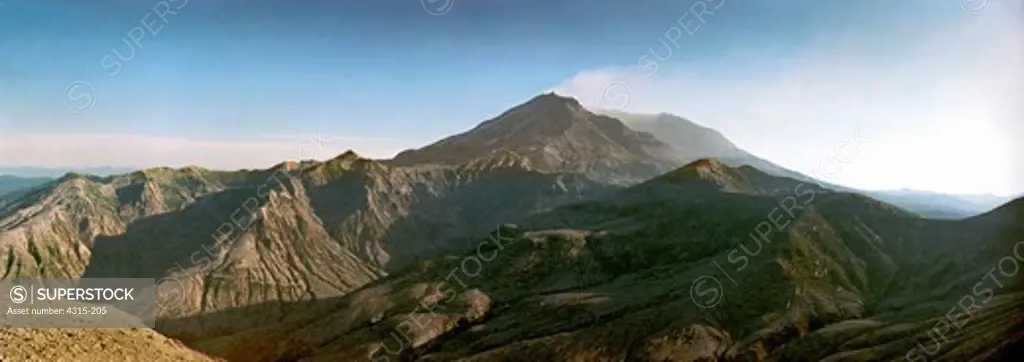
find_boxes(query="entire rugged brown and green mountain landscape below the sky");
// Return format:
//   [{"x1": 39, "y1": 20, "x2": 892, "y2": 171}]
[{"x1": 0, "y1": 94, "x2": 1024, "y2": 361}]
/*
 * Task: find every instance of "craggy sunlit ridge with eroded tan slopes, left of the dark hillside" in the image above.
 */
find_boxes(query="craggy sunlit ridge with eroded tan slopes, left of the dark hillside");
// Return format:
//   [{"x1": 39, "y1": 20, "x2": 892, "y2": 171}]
[{"x1": 0, "y1": 148, "x2": 612, "y2": 338}]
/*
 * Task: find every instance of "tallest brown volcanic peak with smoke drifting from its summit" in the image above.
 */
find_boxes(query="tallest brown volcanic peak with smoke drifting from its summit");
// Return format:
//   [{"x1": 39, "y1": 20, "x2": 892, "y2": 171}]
[{"x1": 389, "y1": 93, "x2": 681, "y2": 185}]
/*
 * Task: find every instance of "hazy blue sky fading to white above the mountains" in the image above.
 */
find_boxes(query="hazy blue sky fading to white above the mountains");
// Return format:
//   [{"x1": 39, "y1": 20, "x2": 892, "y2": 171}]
[{"x1": 0, "y1": 0, "x2": 1024, "y2": 194}]
